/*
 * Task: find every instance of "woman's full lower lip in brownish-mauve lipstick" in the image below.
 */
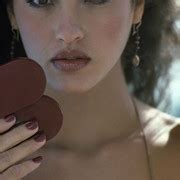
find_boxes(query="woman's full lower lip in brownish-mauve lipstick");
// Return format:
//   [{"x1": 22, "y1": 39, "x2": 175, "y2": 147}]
[{"x1": 53, "y1": 59, "x2": 90, "y2": 72}]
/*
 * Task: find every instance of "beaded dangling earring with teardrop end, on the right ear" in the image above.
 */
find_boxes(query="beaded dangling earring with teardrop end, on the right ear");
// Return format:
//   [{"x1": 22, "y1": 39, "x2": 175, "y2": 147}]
[{"x1": 132, "y1": 21, "x2": 142, "y2": 67}]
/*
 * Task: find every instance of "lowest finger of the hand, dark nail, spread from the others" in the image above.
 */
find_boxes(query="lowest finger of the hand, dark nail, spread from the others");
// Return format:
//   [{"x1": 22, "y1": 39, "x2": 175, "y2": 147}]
[{"x1": 0, "y1": 156, "x2": 42, "y2": 180}]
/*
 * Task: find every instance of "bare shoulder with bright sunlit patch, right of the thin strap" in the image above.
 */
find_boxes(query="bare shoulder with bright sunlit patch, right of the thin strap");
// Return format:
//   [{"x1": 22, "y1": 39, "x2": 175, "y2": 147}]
[{"x1": 135, "y1": 99, "x2": 180, "y2": 180}]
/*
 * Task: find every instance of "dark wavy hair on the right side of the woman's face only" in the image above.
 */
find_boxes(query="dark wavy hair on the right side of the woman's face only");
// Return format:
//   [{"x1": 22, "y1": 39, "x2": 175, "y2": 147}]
[{"x1": 122, "y1": 0, "x2": 179, "y2": 107}]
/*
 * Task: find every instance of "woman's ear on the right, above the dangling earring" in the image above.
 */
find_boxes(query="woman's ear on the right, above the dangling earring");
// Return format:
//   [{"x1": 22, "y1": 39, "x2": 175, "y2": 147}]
[{"x1": 133, "y1": 0, "x2": 145, "y2": 24}]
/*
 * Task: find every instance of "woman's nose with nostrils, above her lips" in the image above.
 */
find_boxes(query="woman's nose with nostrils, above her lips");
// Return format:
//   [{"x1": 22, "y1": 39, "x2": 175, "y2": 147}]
[{"x1": 56, "y1": 17, "x2": 84, "y2": 44}]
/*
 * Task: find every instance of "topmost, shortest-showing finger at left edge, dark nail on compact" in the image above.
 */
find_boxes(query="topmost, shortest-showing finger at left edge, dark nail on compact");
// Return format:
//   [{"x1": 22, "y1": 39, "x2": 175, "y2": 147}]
[{"x1": 0, "y1": 115, "x2": 16, "y2": 133}]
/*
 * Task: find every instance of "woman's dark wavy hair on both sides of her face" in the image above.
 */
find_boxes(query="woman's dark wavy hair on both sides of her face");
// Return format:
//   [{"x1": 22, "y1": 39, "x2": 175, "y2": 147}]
[{"x1": 0, "y1": 0, "x2": 177, "y2": 106}]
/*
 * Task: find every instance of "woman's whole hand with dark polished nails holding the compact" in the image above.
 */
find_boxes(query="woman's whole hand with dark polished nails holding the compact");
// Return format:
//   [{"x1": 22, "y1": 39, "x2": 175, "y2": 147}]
[{"x1": 0, "y1": 116, "x2": 46, "y2": 180}]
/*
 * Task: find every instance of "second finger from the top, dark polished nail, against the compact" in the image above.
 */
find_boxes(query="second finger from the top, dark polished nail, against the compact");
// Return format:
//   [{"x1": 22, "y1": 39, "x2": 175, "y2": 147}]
[{"x1": 0, "y1": 120, "x2": 39, "y2": 153}]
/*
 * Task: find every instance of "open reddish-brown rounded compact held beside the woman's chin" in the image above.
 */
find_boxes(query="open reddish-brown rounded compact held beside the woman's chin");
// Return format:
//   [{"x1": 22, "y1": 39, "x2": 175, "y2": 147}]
[{"x1": 0, "y1": 57, "x2": 63, "y2": 140}]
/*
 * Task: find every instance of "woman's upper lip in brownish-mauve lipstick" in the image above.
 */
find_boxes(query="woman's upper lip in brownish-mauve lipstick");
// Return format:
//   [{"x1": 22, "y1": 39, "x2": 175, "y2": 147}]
[{"x1": 52, "y1": 50, "x2": 91, "y2": 60}]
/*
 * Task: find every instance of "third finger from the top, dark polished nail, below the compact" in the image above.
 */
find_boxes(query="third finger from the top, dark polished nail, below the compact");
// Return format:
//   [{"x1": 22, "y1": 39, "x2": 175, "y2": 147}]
[{"x1": 0, "y1": 133, "x2": 46, "y2": 172}]
